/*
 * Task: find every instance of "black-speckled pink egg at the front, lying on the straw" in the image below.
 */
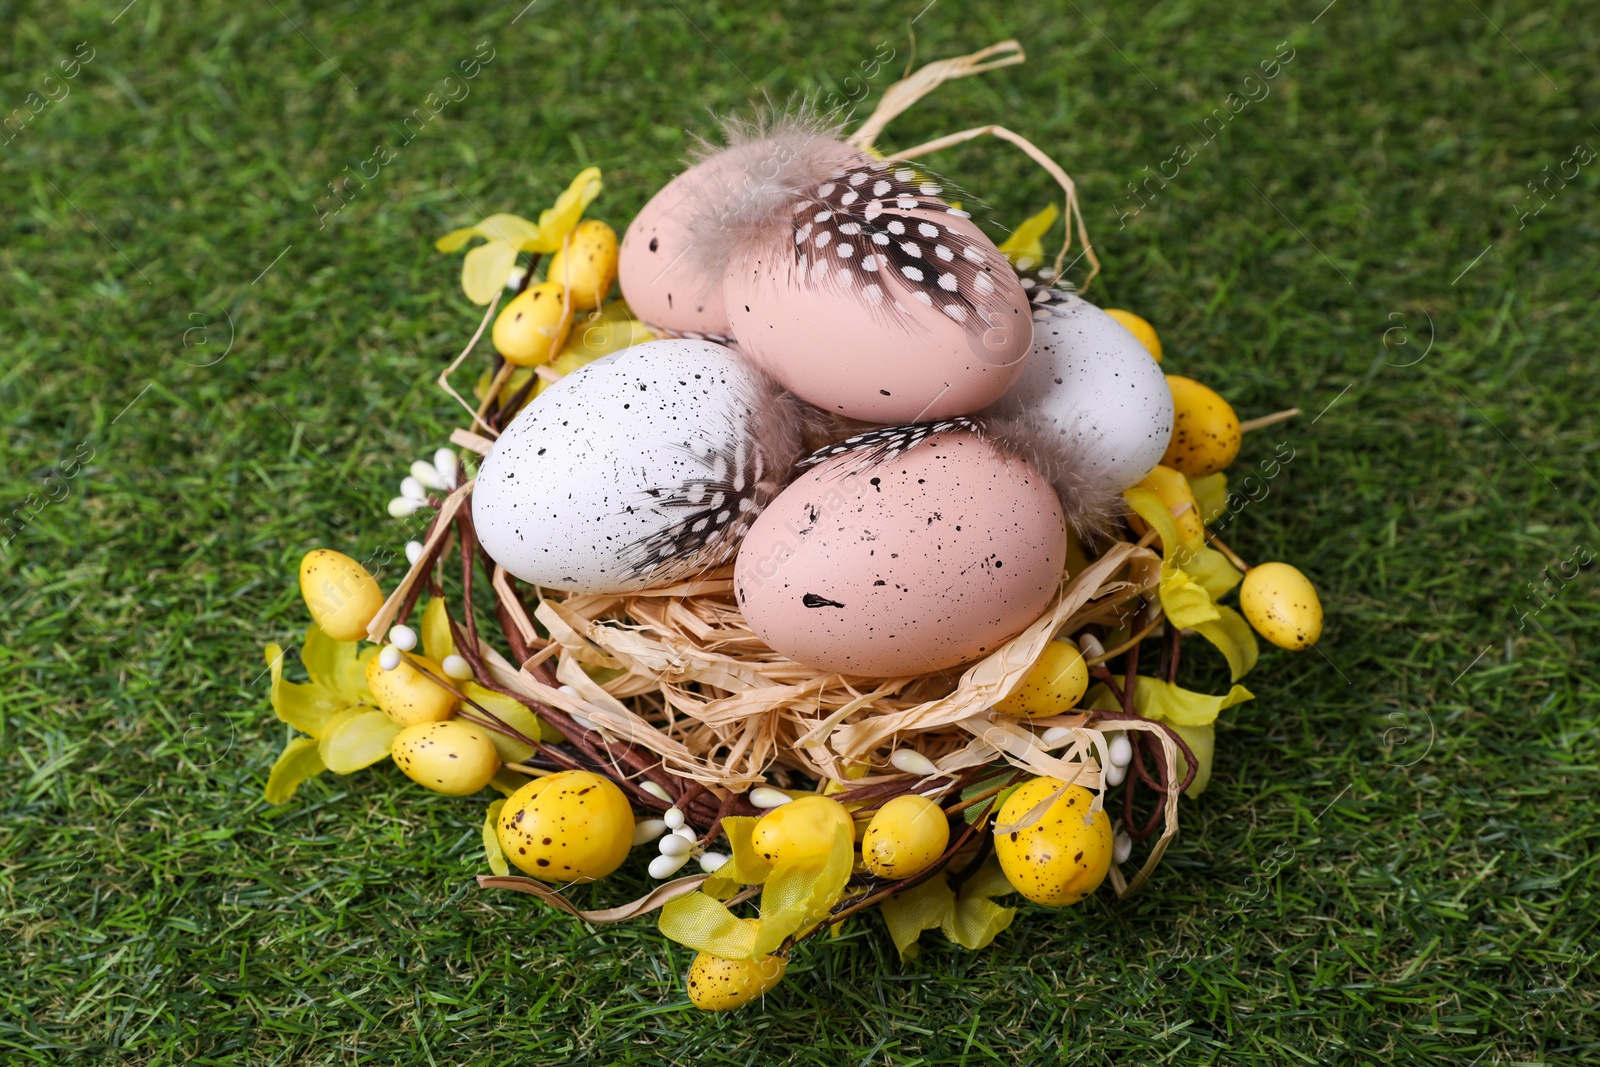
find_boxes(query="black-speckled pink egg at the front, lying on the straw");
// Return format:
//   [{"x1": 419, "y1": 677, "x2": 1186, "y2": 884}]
[{"x1": 734, "y1": 430, "x2": 1067, "y2": 677}]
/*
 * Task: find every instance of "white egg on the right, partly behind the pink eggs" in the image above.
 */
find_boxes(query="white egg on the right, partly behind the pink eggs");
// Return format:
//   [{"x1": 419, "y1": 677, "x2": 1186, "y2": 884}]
[{"x1": 984, "y1": 293, "x2": 1173, "y2": 493}]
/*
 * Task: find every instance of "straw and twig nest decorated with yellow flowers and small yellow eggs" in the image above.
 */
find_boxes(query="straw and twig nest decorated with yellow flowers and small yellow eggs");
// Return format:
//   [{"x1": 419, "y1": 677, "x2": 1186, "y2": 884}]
[{"x1": 267, "y1": 42, "x2": 1320, "y2": 1008}]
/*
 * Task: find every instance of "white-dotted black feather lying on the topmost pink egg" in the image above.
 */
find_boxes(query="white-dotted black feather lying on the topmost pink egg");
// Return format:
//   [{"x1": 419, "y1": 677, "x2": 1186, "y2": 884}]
[{"x1": 792, "y1": 160, "x2": 1011, "y2": 331}]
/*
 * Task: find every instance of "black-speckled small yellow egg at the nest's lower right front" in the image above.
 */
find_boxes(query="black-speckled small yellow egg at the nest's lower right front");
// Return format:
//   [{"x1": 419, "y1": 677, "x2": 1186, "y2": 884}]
[{"x1": 995, "y1": 777, "x2": 1114, "y2": 907}]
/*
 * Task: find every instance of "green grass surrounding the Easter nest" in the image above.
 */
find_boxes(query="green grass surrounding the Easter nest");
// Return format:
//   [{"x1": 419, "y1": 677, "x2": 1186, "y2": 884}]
[{"x1": 0, "y1": 0, "x2": 1600, "y2": 1067}]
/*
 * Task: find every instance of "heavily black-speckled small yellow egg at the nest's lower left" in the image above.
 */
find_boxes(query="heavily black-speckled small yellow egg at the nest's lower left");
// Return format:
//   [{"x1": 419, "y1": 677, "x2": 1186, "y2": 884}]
[{"x1": 494, "y1": 771, "x2": 634, "y2": 883}]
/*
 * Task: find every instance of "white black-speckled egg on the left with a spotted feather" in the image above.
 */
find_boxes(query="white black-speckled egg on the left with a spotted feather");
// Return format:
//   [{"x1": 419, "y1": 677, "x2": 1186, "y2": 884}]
[{"x1": 472, "y1": 339, "x2": 800, "y2": 593}]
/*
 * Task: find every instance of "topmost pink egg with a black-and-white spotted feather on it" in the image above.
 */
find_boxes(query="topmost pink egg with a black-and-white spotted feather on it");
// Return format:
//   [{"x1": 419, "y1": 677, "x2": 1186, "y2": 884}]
[{"x1": 723, "y1": 168, "x2": 1034, "y2": 422}]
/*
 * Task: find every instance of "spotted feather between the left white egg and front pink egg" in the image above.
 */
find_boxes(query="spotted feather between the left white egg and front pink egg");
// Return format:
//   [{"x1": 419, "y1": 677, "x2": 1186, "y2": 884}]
[{"x1": 621, "y1": 384, "x2": 806, "y2": 585}]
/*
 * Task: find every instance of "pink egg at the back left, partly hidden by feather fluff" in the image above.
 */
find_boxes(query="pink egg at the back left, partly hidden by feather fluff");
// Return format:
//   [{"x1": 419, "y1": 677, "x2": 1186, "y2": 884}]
[{"x1": 618, "y1": 163, "x2": 736, "y2": 338}]
